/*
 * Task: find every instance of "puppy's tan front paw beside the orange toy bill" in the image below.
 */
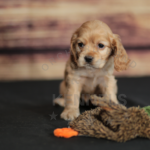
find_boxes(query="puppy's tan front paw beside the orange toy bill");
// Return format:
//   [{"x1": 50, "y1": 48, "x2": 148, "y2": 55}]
[{"x1": 60, "y1": 108, "x2": 80, "y2": 120}]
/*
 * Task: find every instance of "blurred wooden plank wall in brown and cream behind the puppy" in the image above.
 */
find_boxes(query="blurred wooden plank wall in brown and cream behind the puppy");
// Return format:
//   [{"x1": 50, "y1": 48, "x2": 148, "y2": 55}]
[{"x1": 0, "y1": 0, "x2": 150, "y2": 80}]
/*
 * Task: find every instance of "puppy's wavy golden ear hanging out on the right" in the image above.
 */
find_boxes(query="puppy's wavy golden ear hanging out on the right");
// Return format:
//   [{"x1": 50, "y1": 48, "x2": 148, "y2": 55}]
[{"x1": 112, "y1": 34, "x2": 130, "y2": 71}]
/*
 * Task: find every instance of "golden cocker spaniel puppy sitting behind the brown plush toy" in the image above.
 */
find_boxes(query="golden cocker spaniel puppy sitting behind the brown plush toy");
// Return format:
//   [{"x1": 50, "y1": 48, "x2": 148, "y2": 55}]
[{"x1": 54, "y1": 20, "x2": 130, "y2": 120}]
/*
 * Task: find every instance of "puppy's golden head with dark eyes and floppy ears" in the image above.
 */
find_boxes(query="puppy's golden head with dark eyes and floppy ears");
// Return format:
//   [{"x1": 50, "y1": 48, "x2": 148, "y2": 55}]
[{"x1": 71, "y1": 20, "x2": 130, "y2": 71}]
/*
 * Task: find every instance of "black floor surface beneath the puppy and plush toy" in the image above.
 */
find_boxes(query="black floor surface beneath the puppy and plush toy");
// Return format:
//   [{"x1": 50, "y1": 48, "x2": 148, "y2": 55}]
[{"x1": 0, "y1": 77, "x2": 150, "y2": 150}]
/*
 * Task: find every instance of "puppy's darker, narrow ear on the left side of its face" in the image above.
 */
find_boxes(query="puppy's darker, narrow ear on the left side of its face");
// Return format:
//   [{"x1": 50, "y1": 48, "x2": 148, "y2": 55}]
[{"x1": 70, "y1": 32, "x2": 78, "y2": 65}]
